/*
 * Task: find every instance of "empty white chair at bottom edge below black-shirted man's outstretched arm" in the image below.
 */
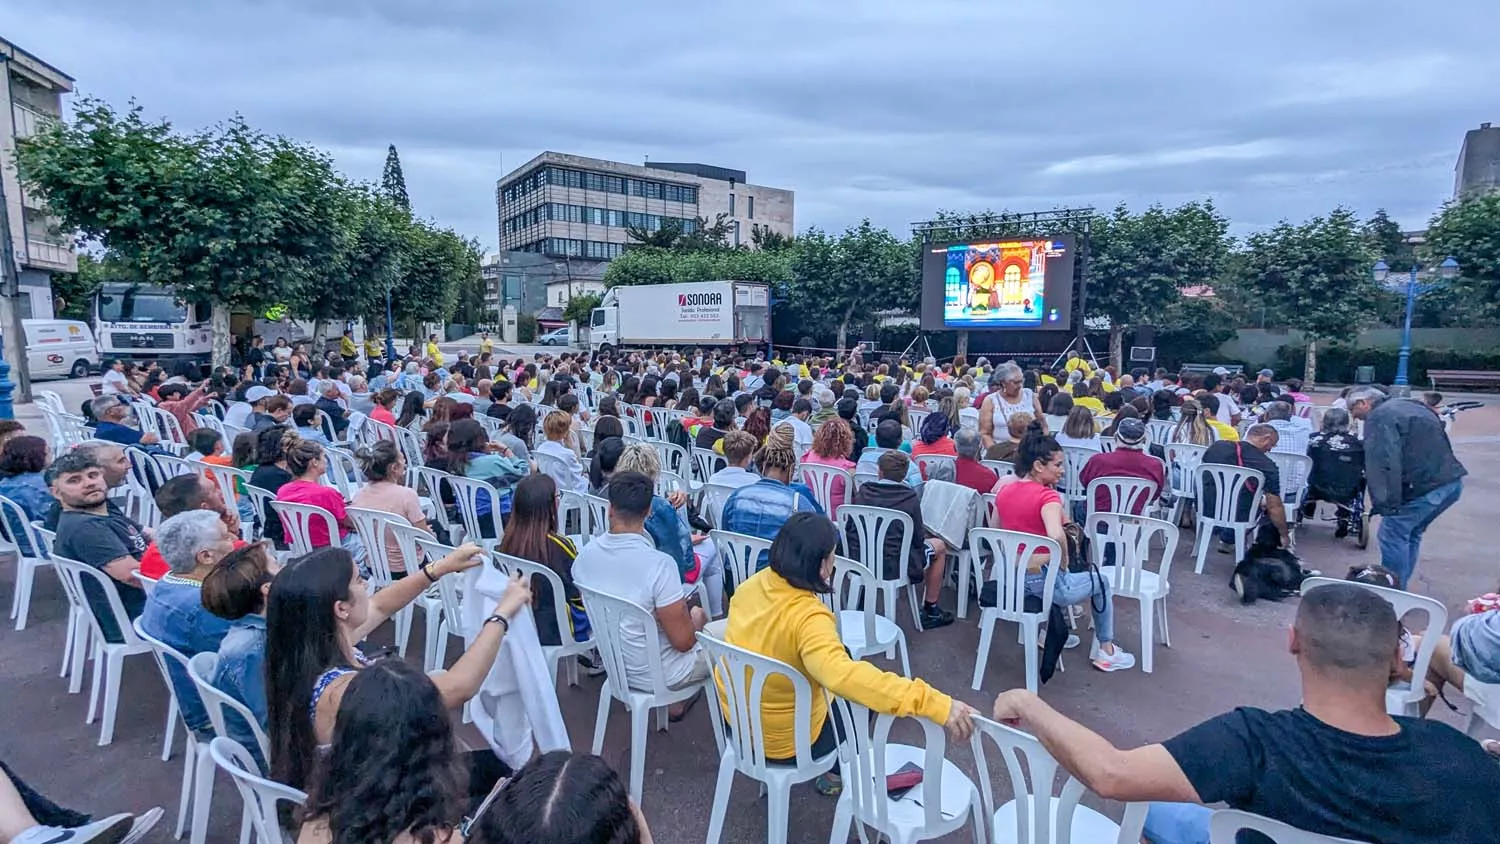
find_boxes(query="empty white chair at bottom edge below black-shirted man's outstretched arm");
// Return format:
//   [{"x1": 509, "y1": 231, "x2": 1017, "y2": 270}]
[{"x1": 969, "y1": 715, "x2": 1149, "y2": 844}]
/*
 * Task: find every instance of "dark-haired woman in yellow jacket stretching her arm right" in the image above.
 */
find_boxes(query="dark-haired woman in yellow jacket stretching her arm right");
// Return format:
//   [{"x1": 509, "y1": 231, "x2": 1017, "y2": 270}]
[{"x1": 719, "y1": 513, "x2": 975, "y2": 795}]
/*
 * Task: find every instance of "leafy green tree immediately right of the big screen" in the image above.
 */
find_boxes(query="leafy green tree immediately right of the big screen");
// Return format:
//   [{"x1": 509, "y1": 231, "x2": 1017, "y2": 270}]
[{"x1": 1086, "y1": 201, "x2": 1232, "y2": 370}]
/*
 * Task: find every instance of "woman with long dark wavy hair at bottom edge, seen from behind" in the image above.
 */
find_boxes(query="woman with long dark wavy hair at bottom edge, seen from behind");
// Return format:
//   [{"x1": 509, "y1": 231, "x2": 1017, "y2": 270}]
[{"x1": 297, "y1": 660, "x2": 474, "y2": 844}]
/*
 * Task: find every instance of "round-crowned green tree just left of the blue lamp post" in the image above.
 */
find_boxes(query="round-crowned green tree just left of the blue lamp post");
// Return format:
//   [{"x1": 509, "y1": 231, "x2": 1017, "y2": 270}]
[{"x1": 1244, "y1": 208, "x2": 1380, "y2": 385}]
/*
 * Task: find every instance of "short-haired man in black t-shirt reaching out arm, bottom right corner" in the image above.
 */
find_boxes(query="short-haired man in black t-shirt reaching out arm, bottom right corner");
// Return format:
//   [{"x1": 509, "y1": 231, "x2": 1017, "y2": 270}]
[{"x1": 995, "y1": 583, "x2": 1500, "y2": 844}]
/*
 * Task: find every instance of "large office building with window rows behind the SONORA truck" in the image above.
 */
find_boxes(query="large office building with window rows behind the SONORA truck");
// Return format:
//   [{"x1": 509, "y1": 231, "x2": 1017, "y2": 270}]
[{"x1": 495, "y1": 151, "x2": 795, "y2": 261}]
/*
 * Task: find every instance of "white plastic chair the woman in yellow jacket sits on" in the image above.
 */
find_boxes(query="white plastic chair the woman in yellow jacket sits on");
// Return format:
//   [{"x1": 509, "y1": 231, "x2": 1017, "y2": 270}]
[{"x1": 698, "y1": 633, "x2": 839, "y2": 844}]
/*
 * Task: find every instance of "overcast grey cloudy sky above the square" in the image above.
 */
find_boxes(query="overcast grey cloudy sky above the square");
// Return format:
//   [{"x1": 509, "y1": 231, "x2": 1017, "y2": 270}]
[{"x1": 0, "y1": 0, "x2": 1500, "y2": 249}]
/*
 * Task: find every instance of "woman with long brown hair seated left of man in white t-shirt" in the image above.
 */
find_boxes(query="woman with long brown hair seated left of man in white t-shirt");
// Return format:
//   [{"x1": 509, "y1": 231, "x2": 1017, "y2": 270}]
[{"x1": 500, "y1": 474, "x2": 582, "y2": 650}]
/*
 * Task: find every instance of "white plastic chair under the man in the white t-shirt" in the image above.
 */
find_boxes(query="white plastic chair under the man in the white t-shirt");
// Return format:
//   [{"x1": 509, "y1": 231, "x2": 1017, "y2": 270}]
[{"x1": 578, "y1": 583, "x2": 716, "y2": 805}]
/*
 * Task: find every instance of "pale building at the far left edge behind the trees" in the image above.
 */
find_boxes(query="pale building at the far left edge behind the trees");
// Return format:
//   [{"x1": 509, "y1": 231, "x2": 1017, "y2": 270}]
[{"x1": 0, "y1": 37, "x2": 78, "y2": 319}]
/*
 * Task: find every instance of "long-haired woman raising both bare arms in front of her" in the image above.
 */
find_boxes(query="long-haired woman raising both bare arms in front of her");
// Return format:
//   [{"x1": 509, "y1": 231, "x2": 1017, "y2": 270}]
[{"x1": 266, "y1": 543, "x2": 531, "y2": 790}]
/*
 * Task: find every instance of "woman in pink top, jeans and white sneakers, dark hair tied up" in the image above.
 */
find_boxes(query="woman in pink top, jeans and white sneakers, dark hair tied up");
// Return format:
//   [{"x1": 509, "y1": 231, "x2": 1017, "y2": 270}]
[{"x1": 995, "y1": 428, "x2": 1136, "y2": 672}]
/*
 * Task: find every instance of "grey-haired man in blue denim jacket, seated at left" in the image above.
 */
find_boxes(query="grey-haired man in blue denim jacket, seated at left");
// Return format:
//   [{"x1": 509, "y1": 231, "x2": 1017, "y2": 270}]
[{"x1": 141, "y1": 510, "x2": 234, "y2": 738}]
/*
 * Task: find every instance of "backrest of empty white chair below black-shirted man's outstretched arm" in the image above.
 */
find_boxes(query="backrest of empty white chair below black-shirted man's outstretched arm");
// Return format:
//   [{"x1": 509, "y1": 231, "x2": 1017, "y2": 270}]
[{"x1": 969, "y1": 715, "x2": 1085, "y2": 844}]
